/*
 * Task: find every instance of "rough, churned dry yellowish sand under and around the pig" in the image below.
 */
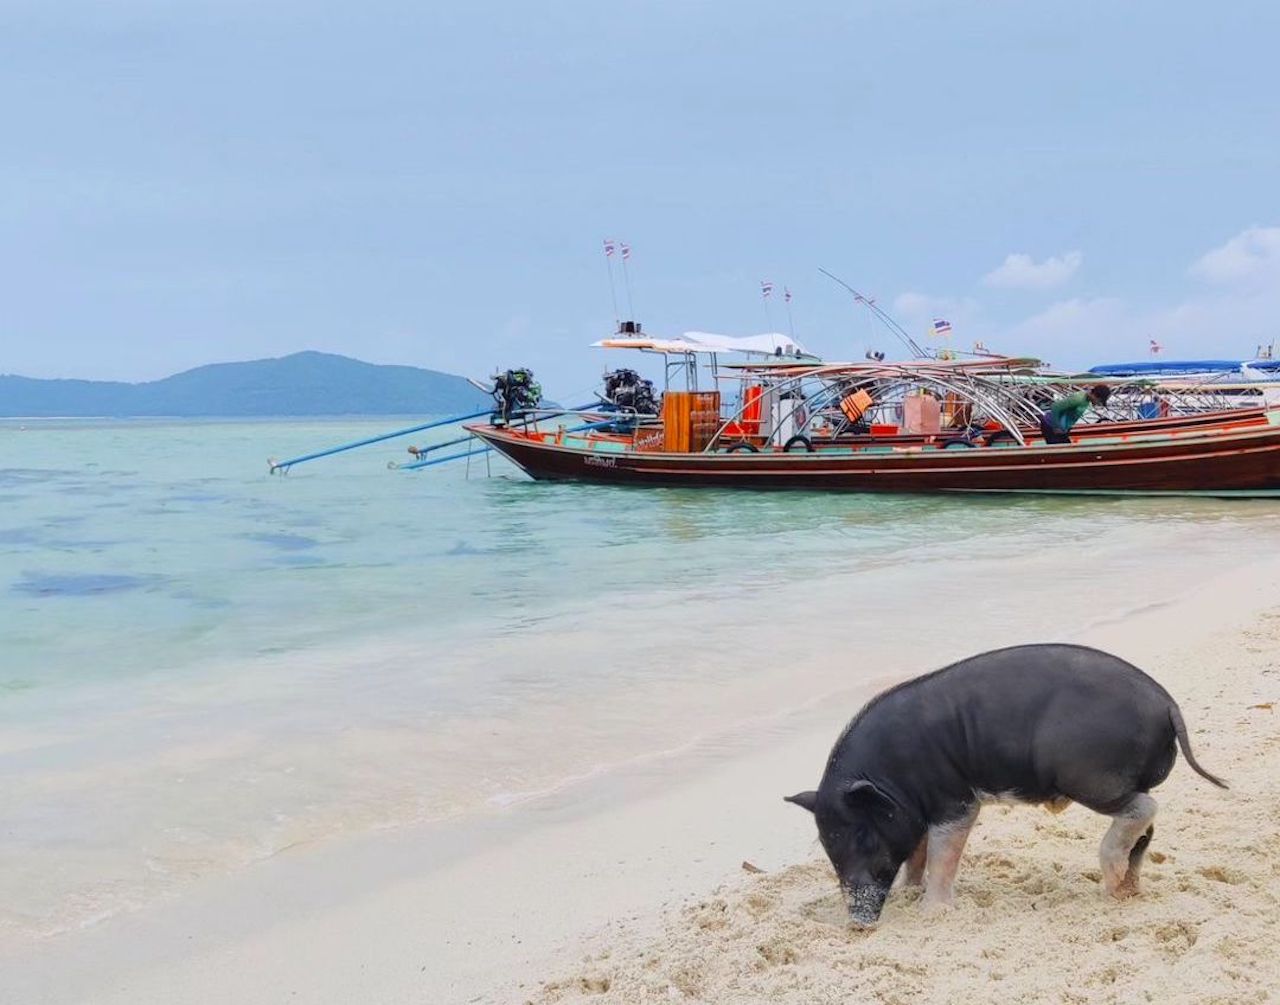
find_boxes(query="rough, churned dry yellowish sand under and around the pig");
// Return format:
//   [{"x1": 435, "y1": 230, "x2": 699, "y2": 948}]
[{"x1": 530, "y1": 611, "x2": 1280, "y2": 1005}]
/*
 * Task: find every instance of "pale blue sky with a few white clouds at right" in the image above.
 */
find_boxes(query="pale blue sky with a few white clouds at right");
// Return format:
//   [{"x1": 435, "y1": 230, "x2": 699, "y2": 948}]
[{"x1": 0, "y1": 0, "x2": 1280, "y2": 394}]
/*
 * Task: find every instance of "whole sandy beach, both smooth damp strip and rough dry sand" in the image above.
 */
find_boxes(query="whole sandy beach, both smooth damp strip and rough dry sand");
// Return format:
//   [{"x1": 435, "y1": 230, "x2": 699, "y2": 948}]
[{"x1": 10, "y1": 562, "x2": 1280, "y2": 1005}]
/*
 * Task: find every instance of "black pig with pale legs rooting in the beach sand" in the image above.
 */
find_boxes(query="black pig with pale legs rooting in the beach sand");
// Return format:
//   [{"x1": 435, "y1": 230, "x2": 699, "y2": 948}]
[{"x1": 787, "y1": 645, "x2": 1226, "y2": 924}]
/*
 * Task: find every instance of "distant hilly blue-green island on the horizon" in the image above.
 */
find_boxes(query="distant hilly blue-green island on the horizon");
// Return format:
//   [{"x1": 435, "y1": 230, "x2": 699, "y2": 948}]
[{"x1": 0, "y1": 352, "x2": 492, "y2": 417}]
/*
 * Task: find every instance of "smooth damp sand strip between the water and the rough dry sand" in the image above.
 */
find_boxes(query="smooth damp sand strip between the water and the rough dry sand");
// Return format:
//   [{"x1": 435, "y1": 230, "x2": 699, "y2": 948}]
[{"x1": 4, "y1": 559, "x2": 1280, "y2": 1002}]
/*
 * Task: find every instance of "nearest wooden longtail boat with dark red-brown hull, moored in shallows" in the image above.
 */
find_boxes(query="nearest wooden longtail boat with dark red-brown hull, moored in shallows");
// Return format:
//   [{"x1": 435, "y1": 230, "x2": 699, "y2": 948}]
[{"x1": 467, "y1": 364, "x2": 1280, "y2": 495}]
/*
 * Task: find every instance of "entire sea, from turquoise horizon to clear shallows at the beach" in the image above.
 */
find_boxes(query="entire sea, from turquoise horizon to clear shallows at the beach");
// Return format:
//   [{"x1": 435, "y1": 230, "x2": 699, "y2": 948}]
[{"x1": 0, "y1": 419, "x2": 1280, "y2": 937}]
